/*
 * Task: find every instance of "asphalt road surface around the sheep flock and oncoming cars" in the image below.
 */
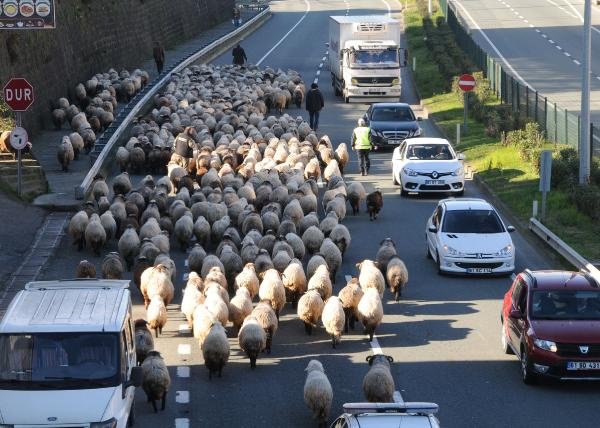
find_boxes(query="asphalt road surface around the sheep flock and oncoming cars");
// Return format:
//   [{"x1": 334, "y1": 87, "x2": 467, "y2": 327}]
[{"x1": 38, "y1": 0, "x2": 600, "y2": 427}]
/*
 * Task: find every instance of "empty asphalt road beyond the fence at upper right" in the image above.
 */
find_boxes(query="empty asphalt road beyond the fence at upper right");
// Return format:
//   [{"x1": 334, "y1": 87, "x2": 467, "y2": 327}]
[{"x1": 450, "y1": 0, "x2": 600, "y2": 123}]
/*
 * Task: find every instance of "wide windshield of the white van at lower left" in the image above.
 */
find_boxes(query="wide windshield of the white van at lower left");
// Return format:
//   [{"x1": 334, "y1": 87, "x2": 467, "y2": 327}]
[{"x1": 0, "y1": 333, "x2": 120, "y2": 389}]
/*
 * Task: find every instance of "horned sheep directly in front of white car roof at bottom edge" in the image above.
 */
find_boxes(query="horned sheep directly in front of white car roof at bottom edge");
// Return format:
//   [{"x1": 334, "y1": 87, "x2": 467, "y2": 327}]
[{"x1": 363, "y1": 354, "x2": 396, "y2": 403}]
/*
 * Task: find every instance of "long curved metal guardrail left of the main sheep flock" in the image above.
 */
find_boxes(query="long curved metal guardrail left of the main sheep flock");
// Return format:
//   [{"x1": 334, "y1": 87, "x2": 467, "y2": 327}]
[{"x1": 75, "y1": 6, "x2": 271, "y2": 199}]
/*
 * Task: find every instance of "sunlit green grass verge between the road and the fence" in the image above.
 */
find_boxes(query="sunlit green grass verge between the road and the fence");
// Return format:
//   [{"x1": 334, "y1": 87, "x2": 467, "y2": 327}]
[{"x1": 404, "y1": 0, "x2": 600, "y2": 262}]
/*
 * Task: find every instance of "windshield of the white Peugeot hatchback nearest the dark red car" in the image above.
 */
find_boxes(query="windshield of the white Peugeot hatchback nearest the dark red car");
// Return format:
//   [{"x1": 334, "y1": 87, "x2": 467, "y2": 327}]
[{"x1": 442, "y1": 210, "x2": 504, "y2": 233}]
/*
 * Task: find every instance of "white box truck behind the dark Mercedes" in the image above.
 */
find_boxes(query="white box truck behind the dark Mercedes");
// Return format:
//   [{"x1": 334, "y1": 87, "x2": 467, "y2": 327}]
[{"x1": 329, "y1": 15, "x2": 406, "y2": 103}]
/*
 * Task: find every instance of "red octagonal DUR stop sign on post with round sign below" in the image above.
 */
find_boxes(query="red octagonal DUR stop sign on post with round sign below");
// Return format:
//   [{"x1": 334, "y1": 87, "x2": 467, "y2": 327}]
[{"x1": 3, "y1": 77, "x2": 34, "y2": 196}]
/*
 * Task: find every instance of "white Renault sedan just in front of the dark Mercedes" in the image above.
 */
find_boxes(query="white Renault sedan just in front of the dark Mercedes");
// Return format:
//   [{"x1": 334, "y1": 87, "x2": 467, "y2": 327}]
[{"x1": 392, "y1": 138, "x2": 465, "y2": 195}]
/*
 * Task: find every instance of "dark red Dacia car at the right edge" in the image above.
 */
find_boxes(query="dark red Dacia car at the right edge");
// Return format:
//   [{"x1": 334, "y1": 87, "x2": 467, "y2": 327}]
[{"x1": 500, "y1": 270, "x2": 600, "y2": 384}]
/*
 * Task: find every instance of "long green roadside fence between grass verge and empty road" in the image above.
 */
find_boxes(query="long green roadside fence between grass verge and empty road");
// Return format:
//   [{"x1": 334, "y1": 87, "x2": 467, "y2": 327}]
[{"x1": 439, "y1": 0, "x2": 584, "y2": 152}]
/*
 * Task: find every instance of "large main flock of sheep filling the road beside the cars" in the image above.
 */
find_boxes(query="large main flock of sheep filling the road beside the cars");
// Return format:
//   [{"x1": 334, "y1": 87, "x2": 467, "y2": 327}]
[{"x1": 69, "y1": 62, "x2": 408, "y2": 423}]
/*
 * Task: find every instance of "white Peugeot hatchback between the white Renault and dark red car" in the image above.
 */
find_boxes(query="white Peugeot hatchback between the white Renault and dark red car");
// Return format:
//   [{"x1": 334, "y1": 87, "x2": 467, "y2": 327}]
[{"x1": 425, "y1": 198, "x2": 515, "y2": 275}]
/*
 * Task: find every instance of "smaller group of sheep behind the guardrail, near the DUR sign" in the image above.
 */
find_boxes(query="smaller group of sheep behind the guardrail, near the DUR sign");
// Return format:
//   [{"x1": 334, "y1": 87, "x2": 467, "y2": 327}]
[{"x1": 52, "y1": 69, "x2": 150, "y2": 171}]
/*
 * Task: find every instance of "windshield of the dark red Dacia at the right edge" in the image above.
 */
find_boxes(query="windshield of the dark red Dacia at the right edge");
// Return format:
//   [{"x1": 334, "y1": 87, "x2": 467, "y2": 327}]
[{"x1": 531, "y1": 290, "x2": 600, "y2": 320}]
